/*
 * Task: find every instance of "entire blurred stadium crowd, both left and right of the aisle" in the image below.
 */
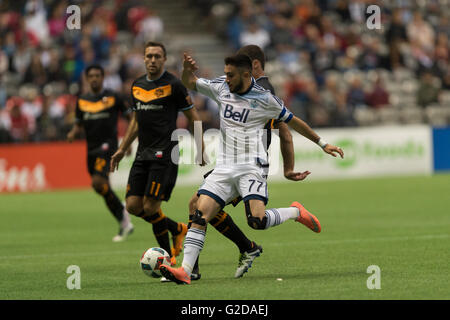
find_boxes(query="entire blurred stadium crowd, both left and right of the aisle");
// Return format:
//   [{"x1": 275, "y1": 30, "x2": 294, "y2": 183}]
[{"x1": 0, "y1": 0, "x2": 450, "y2": 143}]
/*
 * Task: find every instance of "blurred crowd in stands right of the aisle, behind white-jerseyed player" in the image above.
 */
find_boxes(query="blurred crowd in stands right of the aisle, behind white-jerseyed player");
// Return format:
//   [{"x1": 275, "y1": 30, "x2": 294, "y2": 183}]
[{"x1": 211, "y1": 0, "x2": 450, "y2": 127}]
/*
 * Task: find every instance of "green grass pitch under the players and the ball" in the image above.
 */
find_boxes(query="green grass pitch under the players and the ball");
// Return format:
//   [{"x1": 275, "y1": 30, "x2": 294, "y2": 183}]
[{"x1": 0, "y1": 174, "x2": 450, "y2": 300}]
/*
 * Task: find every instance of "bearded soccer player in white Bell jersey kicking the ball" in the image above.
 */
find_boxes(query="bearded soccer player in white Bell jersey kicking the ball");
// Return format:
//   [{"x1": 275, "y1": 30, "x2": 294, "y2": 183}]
[{"x1": 160, "y1": 54, "x2": 344, "y2": 284}]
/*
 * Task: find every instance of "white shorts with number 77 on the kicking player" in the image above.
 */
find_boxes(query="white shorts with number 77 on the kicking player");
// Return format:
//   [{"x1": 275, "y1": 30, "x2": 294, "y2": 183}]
[{"x1": 198, "y1": 164, "x2": 269, "y2": 207}]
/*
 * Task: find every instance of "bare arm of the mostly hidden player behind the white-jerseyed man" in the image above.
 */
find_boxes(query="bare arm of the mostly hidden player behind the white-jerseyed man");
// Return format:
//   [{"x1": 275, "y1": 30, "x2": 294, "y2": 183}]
[{"x1": 274, "y1": 122, "x2": 311, "y2": 181}]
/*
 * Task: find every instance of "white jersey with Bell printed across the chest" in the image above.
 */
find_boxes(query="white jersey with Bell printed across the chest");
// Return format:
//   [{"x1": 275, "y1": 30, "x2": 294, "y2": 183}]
[{"x1": 196, "y1": 76, "x2": 293, "y2": 166}]
